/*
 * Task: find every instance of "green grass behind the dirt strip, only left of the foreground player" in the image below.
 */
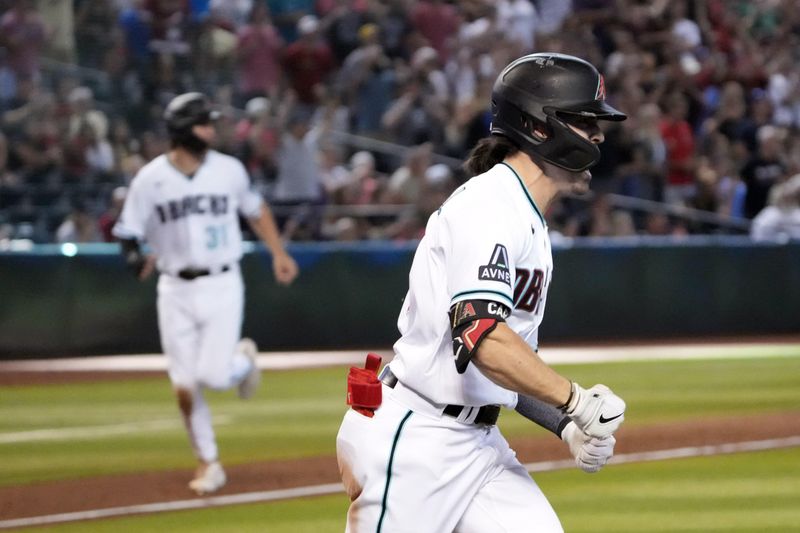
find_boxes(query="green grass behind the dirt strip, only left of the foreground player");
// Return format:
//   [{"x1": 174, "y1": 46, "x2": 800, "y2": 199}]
[{"x1": 0, "y1": 368, "x2": 346, "y2": 486}]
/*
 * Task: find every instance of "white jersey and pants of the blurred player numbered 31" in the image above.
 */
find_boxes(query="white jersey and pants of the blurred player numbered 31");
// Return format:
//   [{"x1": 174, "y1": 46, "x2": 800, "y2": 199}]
[{"x1": 114, "y1": 150, "x2": 262, "y2": 463}]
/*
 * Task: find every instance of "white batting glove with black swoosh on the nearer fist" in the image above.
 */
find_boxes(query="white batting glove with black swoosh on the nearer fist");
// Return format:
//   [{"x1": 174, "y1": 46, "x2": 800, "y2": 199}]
[{"x1": 561, "y1": 382, "x2": 625, "y2": 438}]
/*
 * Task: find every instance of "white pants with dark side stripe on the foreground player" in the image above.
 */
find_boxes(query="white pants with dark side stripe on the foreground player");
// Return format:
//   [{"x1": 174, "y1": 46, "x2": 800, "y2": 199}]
[{"x1": 337, "y1": 384, "x2": 563, "y2": 533}]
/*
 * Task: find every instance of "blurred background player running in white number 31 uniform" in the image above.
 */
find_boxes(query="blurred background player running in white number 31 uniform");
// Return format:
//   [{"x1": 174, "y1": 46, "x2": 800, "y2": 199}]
[{"x1": 113, "y1": 93, "x2": 298, "y2": 494}]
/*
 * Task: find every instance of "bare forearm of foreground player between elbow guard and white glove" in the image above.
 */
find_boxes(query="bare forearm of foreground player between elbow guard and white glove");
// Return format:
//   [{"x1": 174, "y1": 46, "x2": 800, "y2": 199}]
[{"x1": 472, "y1": 323, "x2": 571, "y2": 406}]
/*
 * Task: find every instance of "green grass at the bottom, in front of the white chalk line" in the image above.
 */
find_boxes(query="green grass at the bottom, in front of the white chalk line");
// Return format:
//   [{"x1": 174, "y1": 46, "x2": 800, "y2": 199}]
[{"x1": 31, "y1": 448, "x2": 800, "y2": 533}]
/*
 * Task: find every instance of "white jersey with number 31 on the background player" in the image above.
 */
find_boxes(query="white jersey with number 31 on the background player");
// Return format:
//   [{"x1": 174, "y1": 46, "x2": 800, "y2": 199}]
[{"x1": 114, "y1": 150, "x2": 262, "y2": 274}]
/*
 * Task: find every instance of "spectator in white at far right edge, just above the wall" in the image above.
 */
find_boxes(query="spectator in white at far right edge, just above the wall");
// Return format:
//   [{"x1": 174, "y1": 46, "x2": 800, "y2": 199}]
[{"x1": 750, "y1": 174, "x2": 800, "y2": 242}]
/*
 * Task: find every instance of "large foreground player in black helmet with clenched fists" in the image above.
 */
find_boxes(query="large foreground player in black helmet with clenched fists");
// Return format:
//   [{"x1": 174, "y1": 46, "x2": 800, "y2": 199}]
[{"x1": 337, "y1": 54, "x2": 625, "y2": 533}]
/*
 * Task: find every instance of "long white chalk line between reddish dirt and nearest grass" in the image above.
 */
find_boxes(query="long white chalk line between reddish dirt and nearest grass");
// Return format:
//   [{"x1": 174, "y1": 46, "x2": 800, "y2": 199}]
[{"x1": 0, "y1": 435, "x2": 800, "y2": 529}]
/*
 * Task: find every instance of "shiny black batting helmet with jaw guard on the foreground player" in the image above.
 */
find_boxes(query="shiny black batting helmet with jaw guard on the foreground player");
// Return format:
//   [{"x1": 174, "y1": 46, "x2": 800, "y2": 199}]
[{"x1": 491, "y1": 53, "x2": 627, "y2": 172}]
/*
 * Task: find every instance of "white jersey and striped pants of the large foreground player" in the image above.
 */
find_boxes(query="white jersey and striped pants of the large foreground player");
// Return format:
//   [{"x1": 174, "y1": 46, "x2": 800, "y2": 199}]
[{"x1": 336, "y1": 164, "x2": 563, "y2": 533}]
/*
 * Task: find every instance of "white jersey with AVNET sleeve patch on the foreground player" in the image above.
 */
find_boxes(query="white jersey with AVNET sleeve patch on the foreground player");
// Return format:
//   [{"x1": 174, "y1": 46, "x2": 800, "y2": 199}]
[{"x1": 391, "y1": 163, "x2": 553, "y2": 408}]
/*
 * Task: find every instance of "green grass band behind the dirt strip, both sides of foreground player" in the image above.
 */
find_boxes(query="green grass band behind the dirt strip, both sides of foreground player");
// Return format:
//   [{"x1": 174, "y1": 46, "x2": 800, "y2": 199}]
[{"x1": 0, "y1": 357, "x2": 800, "y2": 486}]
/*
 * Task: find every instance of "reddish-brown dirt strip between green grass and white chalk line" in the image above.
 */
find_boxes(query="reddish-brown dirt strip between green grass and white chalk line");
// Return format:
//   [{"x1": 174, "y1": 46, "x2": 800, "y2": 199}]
[{"x1": 0, "y1": 390, "x2": 800, "y2": 520}]
